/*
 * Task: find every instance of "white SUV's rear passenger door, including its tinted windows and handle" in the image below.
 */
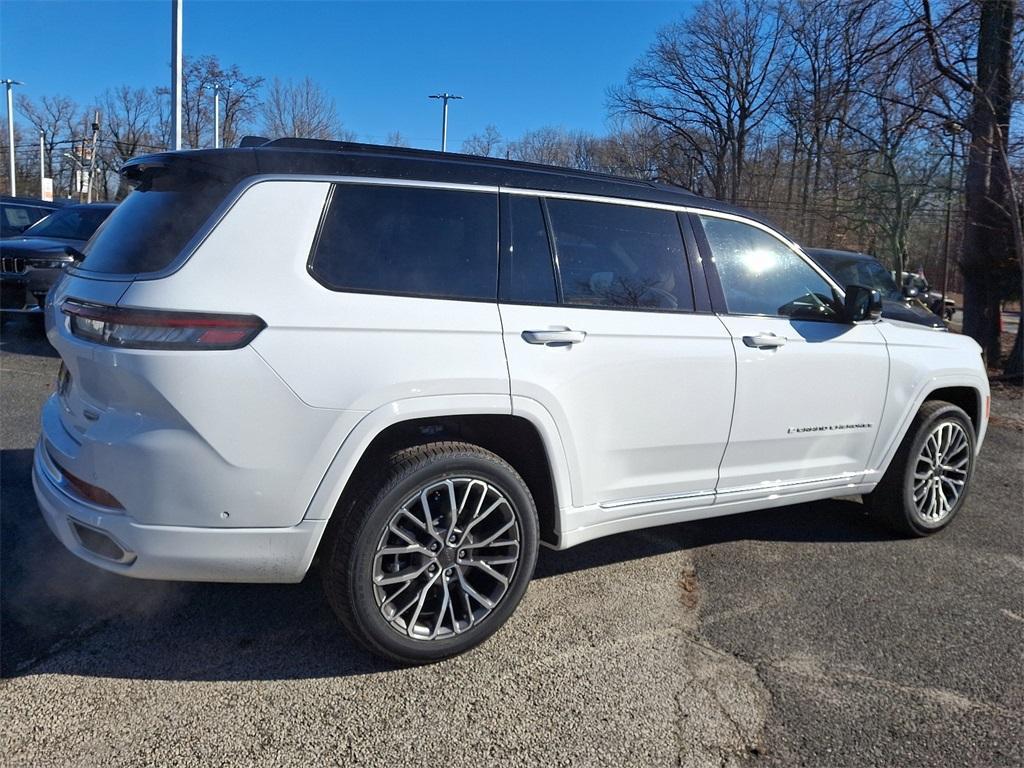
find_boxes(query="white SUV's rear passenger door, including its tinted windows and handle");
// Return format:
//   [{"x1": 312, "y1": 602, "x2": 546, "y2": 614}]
[{"x1": 500, "y1": 194, "x2": 735, "y2": 527}]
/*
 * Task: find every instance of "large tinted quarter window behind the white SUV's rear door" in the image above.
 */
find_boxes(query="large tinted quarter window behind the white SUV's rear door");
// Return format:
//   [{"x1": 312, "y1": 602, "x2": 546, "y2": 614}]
[{"x1": 309, "y1": 184, "x2": 498, "y2": 301}]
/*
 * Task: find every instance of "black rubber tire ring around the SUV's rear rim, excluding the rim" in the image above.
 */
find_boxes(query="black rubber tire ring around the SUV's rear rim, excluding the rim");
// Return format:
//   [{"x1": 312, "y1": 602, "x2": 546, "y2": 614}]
[{"x1": 347, "y1": 453, "x2": 539, "y2": 663}]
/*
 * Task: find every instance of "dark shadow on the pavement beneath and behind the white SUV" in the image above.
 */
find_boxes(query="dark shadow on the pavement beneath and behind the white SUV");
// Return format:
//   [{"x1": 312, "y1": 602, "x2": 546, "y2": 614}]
[{"x1": 0, "y1": 442, "x2": 887, "y2": 681}]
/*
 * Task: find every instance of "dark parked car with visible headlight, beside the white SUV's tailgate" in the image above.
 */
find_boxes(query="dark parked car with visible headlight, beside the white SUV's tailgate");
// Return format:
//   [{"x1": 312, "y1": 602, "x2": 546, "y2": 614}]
[{"x1": 0, "y1": 203, "x2": 115, "y2": 313}]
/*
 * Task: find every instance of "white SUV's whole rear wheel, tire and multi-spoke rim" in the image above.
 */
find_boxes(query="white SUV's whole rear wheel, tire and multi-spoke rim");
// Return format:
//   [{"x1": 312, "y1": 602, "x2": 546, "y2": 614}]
[{"x1": 321, "y1": 442, "x2": 540, "y2": 665}]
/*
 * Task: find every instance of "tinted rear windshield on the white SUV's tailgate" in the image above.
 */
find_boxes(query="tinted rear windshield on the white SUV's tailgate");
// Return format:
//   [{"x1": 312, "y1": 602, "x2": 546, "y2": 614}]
[{"x1": 80, "y1": 174, "x2": 230, "y2": 274}]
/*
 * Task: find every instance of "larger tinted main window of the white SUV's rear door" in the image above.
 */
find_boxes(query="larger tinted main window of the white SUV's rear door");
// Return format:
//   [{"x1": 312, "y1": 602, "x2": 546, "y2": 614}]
[{"x1": 548, "y1": 199, "x2": 693, "y2": 310}]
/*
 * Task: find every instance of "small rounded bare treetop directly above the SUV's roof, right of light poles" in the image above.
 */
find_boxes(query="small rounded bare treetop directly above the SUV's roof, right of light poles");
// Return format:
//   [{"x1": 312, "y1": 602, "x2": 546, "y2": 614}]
[{"x1": 260, "y1": 77, "x2": 351, "y2": 139}]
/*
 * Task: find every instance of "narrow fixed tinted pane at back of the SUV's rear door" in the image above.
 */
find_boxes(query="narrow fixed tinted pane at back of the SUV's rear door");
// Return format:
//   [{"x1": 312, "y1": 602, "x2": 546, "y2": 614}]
[{"x1": 501, "y1": 195, "x2": 558, "y2": 304}]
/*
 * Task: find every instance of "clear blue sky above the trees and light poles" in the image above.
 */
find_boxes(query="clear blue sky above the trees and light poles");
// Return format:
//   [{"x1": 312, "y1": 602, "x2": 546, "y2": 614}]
[{"x1": 0, "y1": 0, "x2": 693, "y2": 147}]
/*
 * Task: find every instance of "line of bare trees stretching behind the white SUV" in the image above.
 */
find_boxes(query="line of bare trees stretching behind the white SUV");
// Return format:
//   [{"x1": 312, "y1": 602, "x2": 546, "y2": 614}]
[{"x1": 4, "y1": 0, "x2": 1024, "y2": 373}]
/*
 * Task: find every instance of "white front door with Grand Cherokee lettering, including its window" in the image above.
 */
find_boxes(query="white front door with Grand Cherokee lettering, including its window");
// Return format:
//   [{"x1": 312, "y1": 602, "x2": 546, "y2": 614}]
[{"x1": 692, "y1": 214, "x2": 889, "y2": 503}]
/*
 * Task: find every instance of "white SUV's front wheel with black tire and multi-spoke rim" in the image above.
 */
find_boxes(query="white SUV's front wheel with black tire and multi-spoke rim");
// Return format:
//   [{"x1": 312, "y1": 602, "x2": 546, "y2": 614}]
[{"x1": 864, "y1": 400, "x2": 976, "y2": 537}]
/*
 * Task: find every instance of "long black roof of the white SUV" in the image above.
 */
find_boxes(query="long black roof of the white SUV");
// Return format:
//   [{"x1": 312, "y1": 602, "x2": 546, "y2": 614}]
[{"x1": 122, "y1": 137, "x2": 774, "y2": 227}]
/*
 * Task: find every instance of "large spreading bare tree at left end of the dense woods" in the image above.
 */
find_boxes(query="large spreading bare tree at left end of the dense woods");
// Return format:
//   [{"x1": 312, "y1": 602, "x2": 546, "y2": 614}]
[{"x1": 611, "y1": 0, "x2": 785, "y2": 201}]
